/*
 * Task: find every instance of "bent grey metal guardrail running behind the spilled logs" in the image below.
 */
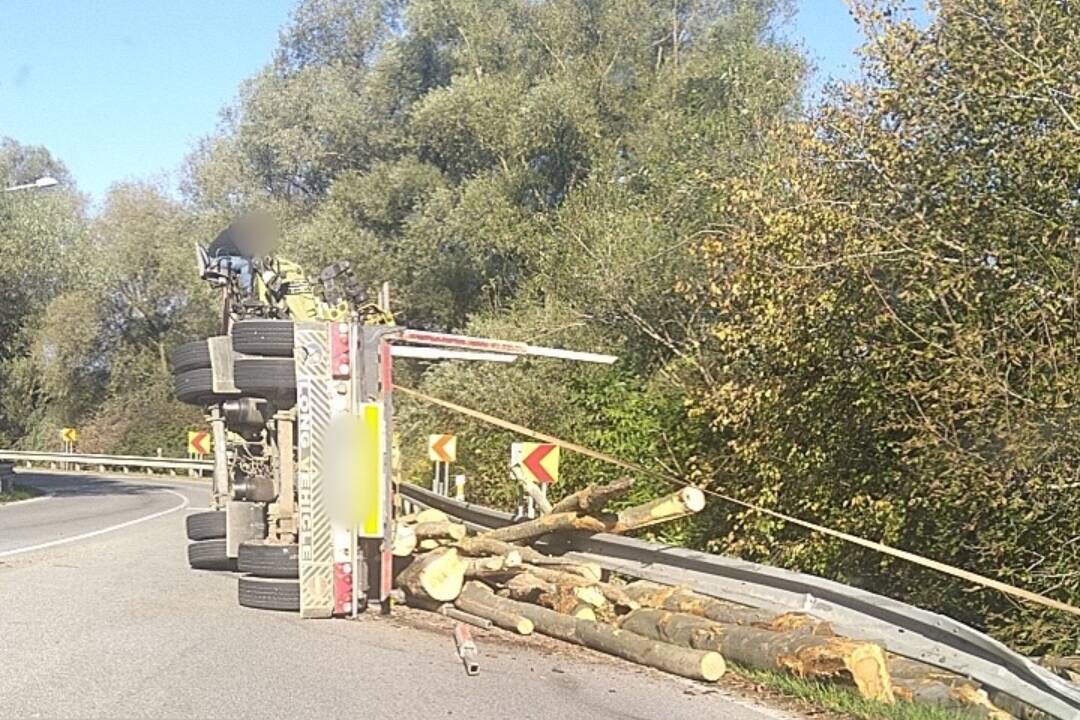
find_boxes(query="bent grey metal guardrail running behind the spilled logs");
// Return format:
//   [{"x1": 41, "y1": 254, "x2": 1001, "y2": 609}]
[{"x1": 401, "y1": 485, "x2": 1080, "y2": 720}]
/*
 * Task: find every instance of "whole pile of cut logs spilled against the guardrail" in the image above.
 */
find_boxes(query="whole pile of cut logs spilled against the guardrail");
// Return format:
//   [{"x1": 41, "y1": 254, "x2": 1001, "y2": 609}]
[{"x1": 394, "y1": 480, "x2": 1032, "y2": 720}]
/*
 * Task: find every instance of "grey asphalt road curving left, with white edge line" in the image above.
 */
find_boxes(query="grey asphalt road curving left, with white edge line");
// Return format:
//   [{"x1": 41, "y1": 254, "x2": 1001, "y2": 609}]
[{"x1": 0, "y1": 475, "x2": 789, "y2": 720}]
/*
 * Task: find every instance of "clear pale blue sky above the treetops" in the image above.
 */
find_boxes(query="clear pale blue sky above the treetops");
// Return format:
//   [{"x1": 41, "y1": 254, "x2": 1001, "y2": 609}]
[{"x1": 0, "y1": 0, "x2": 860, "y2": 200}]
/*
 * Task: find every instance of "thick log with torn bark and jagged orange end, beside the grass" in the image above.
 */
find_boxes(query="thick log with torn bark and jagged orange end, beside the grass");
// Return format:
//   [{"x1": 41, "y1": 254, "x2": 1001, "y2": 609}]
[{"x1": 620, "y1": 609, "x2": 894, "y2": 703}]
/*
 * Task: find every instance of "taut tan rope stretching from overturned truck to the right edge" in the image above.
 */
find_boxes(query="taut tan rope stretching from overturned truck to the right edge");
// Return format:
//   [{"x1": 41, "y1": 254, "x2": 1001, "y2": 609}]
[{"x1": 394, "y1": 384, "x2": 1080, "y2": 615}]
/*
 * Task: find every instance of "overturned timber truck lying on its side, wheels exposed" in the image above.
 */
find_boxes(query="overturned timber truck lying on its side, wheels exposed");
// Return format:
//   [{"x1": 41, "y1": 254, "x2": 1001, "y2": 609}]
[{"x1": 165, "y1": 215, "x2": 616, "y2": 617}]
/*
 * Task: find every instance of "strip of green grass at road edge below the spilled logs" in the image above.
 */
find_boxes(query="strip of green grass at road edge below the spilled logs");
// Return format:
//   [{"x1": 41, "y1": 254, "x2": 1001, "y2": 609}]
[{"x1": 728, "y1": 662, "x2": 970, "y2": 720}]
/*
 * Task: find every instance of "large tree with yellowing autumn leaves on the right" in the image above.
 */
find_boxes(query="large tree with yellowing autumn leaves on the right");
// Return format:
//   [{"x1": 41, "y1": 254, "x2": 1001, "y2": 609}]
[{"x1": 687, "y1": 0, "x2": 1080, "y2": 651}]
